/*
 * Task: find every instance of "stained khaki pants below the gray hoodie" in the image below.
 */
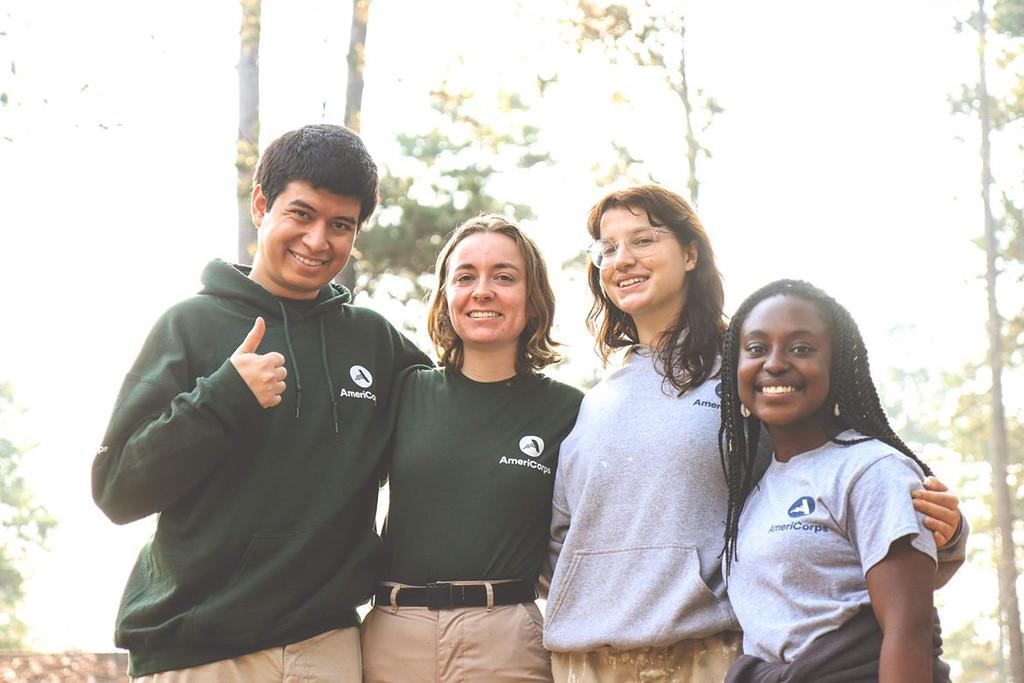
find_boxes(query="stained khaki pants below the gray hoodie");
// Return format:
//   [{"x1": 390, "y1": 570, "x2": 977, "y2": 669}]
[{"x1": 551, "y1": 633, "x2": 743, "y2": 683}]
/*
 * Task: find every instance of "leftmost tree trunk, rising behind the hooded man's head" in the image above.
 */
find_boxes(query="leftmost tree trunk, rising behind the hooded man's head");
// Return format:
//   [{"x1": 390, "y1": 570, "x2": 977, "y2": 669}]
[{"x1": 234, "y1": 0, "x2": 260, "y2": 263}]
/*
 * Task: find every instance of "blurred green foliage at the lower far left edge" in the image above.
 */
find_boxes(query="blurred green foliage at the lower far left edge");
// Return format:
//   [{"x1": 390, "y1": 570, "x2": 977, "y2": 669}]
[{"x1": 0, "y1": 382, "x2": 56, "y2": 649}]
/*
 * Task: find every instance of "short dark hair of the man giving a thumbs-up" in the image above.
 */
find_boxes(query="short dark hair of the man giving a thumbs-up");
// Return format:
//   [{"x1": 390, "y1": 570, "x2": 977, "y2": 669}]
[{"x1": 253, "y1": 124, "x2": 378, "y2": 225}]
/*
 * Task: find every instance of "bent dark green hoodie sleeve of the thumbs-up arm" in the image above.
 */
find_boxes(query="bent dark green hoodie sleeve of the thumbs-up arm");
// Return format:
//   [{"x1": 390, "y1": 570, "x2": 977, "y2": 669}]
[{"x1": 92, "y1": 313, "x2": 262, "y2": 524}]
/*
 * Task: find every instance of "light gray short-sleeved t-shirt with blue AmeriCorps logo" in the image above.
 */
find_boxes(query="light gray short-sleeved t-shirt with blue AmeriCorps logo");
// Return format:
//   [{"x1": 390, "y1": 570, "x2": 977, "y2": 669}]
[{"x1": 728, "y1": 431, "x2": 935, "y2": 663}]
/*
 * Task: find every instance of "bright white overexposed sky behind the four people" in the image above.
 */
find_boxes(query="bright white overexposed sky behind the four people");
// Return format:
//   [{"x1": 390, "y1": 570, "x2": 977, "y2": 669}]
[{"x1": 0, "y1": 0, "x2": 1012, "y2": 663}]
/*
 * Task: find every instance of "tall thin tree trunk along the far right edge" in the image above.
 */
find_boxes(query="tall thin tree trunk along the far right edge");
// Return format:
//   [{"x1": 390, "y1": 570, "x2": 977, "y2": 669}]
[{"x1": 978, "y1": 0, "x2": 1024, "y2": 683}]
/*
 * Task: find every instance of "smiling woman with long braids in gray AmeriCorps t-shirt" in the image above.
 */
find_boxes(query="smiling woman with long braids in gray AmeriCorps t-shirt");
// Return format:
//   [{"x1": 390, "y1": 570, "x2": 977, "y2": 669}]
[{"x1": 722, "y1": 281, "x2": 948, "y2": 682}]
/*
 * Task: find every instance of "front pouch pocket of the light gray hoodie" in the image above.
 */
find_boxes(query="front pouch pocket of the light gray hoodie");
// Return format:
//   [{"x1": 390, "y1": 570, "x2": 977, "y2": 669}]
[{"x1": 545, "y1": 544, "x2": 735, "y2": 650}]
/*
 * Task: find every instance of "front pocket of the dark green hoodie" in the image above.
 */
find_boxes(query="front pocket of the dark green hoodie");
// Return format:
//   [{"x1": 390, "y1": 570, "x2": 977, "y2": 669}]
[{"x1": 186, "y1": 526, "x2": 341, "y2": 644}]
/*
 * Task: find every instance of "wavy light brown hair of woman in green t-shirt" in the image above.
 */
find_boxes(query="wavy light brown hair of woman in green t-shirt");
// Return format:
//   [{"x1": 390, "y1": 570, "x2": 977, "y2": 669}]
[{"x1": 427, "y1": 214, "x2": 562, "y2": 374}]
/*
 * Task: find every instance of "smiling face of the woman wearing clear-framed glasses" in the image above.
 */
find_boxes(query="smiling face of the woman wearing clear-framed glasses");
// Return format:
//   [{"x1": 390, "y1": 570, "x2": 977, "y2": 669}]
[{"x1": 600, "y1": 206, "x2": 696, "y2": 344}]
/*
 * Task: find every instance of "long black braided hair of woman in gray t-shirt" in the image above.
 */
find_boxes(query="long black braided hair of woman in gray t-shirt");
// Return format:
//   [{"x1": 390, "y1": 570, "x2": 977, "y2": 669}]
[{"x1": 718, "y1": 280, "x2": 932, "y2": 574}]
